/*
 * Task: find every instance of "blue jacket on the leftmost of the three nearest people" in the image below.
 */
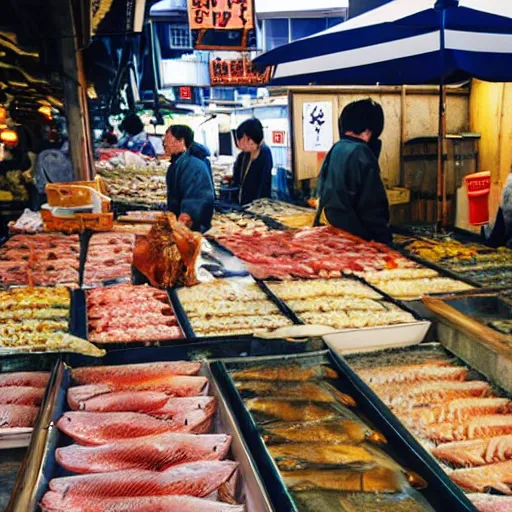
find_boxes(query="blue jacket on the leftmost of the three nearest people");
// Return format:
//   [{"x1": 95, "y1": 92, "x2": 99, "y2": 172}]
[{"x1": 166, "y1": 143, "x2": 214, "y2": 232}]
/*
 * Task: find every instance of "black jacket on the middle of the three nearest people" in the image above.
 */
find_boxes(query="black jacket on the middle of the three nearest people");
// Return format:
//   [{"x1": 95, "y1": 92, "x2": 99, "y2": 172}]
[{"x1": 233, "y1": 144, "x2": 274, "y2": 205}]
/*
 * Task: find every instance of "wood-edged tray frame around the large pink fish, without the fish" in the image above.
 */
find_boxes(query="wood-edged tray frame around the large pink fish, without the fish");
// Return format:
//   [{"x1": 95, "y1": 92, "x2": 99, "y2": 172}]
[{"x1": 6, "y1": 347, "x2": 273, "y2": 512}]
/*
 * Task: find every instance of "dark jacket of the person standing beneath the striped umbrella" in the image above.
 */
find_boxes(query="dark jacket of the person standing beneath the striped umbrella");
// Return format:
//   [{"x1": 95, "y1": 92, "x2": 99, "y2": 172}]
[{"x1": 318, "y1": 136, "x2": 392, "y2": 244}]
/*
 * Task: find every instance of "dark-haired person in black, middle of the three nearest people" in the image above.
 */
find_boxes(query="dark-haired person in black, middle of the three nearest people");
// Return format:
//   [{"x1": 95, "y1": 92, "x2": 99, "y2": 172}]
[{"x1": 233, "y1": 119, "x2": 274, "y2": 205}]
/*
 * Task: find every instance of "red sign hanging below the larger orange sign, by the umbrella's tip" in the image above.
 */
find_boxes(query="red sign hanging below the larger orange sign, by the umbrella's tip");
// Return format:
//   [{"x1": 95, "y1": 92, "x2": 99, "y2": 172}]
[{"x1": 210, "y1": 57, "x2": 271, "y2": 87}]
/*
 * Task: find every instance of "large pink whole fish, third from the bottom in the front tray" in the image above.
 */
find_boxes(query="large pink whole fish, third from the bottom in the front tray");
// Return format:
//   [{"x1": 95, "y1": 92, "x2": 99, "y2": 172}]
[{"x1": 55, "y1": 434, "x2": 231, "y2": 473}]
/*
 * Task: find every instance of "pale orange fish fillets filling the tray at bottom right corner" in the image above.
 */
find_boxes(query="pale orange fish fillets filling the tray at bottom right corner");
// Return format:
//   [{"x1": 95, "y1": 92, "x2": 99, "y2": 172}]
[{"x1": 346, "y1": 343, "x2": 512, "y2": 511}]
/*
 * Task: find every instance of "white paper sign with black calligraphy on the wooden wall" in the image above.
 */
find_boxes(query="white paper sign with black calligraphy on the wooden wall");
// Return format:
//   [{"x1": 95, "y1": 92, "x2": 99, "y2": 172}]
[{"x1": 302, "y1": 101, "x2": 334, "y2": 153}]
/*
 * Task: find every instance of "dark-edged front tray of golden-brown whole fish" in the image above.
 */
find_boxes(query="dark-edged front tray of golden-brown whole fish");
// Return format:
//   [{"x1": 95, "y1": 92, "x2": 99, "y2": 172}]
[{"x1": 211, "y1": 352, "x2": 473, "y2": 512}]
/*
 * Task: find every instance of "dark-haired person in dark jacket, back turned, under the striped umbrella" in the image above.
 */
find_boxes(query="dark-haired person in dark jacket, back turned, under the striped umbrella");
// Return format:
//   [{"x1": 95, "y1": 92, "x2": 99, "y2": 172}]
[{"x1": 316, "y1": 99, "x2": 392, "y2": 244}]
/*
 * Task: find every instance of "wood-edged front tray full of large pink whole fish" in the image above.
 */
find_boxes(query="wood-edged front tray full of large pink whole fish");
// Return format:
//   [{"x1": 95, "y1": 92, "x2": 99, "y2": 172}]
[{"x1": 7, "y1": 349, "x2": 272, "y2": 512}]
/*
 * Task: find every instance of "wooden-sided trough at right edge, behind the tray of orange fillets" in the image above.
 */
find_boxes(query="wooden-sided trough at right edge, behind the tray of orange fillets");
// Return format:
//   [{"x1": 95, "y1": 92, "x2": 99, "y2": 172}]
[{"x1": 425, "y1": 293, "x2": 512, "y2": 392}]
